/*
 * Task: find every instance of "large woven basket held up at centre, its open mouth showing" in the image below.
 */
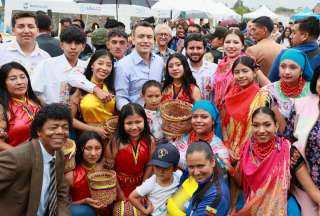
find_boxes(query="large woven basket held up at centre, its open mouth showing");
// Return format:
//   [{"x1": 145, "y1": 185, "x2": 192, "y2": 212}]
[{"x1": 160, "y1": 100, "x2": 192, "y2": 137}]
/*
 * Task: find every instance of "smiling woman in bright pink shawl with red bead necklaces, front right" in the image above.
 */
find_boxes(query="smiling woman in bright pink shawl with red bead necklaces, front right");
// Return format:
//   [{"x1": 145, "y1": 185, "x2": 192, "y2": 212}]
[{"x1": 232, "y1": 107, "x2": 320, "y2": 216}]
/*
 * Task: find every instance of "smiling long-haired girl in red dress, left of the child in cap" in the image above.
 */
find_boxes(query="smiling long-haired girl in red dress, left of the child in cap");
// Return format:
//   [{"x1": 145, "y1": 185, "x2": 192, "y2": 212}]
[{"x1": 106, "y1": 103, "x2": 155, "y2": 200}]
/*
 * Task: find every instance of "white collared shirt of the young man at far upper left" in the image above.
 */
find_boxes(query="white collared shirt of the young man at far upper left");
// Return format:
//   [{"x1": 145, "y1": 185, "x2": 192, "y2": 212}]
[{"x1": 0, "y1": 40, "x2": 50, "y2": 75}]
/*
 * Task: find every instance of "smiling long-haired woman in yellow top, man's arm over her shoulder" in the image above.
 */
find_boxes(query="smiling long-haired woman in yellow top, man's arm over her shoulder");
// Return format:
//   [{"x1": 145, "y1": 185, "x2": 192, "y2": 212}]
[{"x1": 71, "y1": 50, "x2": 116, "y2": 138}]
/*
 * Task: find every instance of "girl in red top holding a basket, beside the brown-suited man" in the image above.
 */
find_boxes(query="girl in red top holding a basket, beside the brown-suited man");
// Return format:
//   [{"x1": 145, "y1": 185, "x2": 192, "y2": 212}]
[{"x1": 65, "y1": 131, "x2": 105, "y2": 216}]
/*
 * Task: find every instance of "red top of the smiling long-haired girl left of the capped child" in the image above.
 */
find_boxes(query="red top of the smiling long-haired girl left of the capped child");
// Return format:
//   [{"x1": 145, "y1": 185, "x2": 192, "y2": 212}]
[{"x1": 115, "y1": 140, "x2": 150, "y2": 197}]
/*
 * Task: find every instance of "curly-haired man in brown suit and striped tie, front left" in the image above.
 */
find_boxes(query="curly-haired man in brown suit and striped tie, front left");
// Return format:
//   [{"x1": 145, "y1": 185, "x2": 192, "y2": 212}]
[{"x1": 0, "y1": 104, "x2": 72, "y2": 216}]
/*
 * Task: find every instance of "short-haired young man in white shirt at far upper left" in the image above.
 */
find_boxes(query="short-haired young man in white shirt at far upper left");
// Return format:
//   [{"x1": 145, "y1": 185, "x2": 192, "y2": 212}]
[{"x1": 0, "y1": 12, "x2": 50, "y2": 75}]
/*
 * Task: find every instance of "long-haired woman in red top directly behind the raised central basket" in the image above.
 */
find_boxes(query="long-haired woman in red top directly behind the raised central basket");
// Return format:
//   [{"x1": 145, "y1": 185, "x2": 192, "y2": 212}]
[{"x1": 161, "y1": 53, "x2": 201, "y2": 104}]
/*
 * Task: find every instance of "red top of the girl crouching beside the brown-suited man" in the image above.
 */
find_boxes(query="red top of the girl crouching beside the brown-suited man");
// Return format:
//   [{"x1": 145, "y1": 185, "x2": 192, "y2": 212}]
[{"x1": 70, "y1": 165, "x2": 91, "y2": 201}]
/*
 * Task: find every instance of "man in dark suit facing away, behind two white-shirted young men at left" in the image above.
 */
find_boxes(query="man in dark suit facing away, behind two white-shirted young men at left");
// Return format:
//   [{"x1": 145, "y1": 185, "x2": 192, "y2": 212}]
[{"x1": 36, "y1": 13, "x2": 63, "y2": 57}]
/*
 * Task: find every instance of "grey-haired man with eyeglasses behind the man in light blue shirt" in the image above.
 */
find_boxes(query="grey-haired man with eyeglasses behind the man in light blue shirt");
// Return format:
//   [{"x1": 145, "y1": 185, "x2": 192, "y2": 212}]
[{"x1": 153, "y1": 24, "x2": 175, "y2": 64}]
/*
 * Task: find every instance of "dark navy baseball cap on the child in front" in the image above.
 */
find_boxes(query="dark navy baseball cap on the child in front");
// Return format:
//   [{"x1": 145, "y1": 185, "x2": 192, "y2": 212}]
[{"x1": 148, "y1": 143, "x2": 180, "y2": 168}]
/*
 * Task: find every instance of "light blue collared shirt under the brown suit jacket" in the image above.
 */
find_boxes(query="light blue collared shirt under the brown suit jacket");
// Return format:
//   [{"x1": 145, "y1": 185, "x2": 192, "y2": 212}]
[{"x1": 37, "y1": 140, "x2": 55, "y2": 216}]
